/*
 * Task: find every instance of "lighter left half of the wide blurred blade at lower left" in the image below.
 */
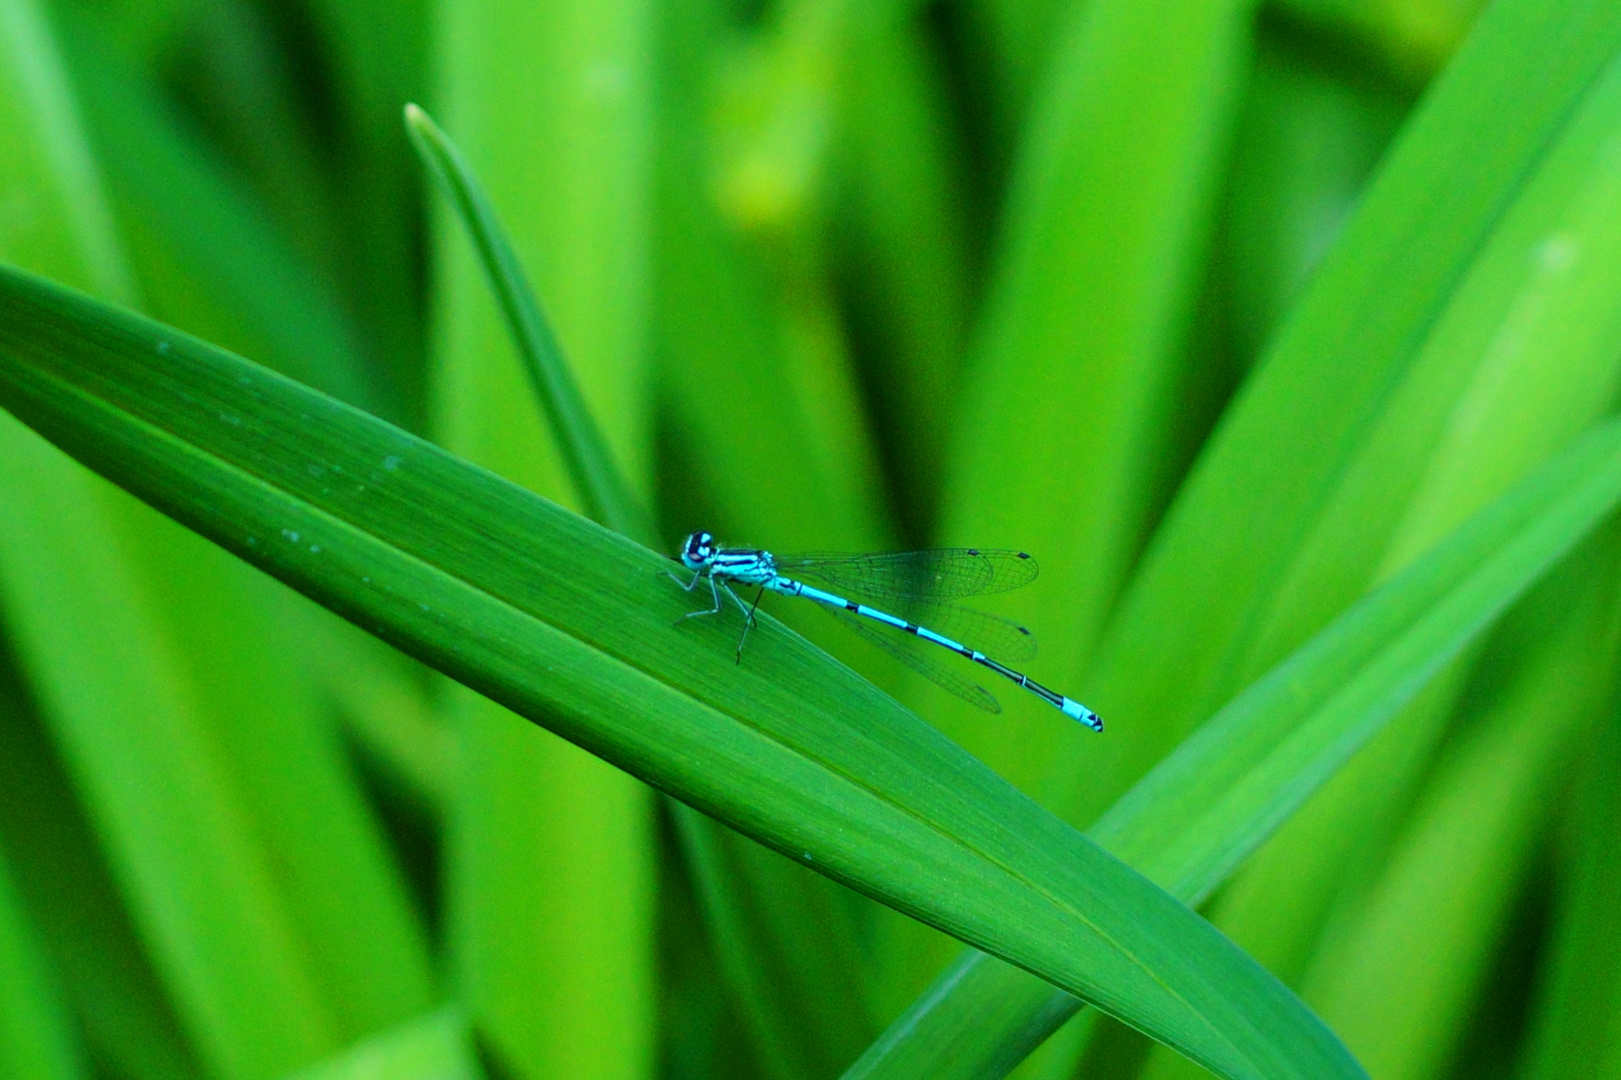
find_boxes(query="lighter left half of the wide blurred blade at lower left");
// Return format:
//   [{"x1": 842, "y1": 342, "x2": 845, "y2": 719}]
[{"x1": 0, "y1": 405, "x2": 336, "y2": 1080}]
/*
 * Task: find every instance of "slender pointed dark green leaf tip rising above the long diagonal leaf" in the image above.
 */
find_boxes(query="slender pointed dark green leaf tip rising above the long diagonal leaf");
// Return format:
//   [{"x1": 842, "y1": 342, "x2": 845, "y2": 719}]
[{"x1": 405, "y1": 105, "x2": 655, "y2": 545}]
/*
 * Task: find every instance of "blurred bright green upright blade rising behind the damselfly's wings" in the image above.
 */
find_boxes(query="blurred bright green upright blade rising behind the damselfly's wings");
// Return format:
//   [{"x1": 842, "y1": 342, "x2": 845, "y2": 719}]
[{"x1": 885, "y1": 0, "x2": 1255, "y2": 1004}]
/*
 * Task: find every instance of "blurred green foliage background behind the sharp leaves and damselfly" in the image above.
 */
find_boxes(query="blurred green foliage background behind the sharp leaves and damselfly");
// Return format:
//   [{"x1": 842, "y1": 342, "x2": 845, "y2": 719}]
[{"x1": 0, "y1": 0, "x2": 1621, "y2": 1080}]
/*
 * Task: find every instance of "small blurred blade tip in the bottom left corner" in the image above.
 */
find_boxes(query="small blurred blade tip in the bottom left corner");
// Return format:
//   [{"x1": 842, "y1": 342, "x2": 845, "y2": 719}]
[{"x1": 0, "y1": 851, "x2": 86, "y2": 1080}]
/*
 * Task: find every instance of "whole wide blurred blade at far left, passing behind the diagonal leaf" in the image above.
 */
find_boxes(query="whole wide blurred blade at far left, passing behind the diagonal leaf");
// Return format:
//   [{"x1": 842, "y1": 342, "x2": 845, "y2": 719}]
[{"x1": 0, "y1": 4, "x2": 428, "y2": 1077}]
